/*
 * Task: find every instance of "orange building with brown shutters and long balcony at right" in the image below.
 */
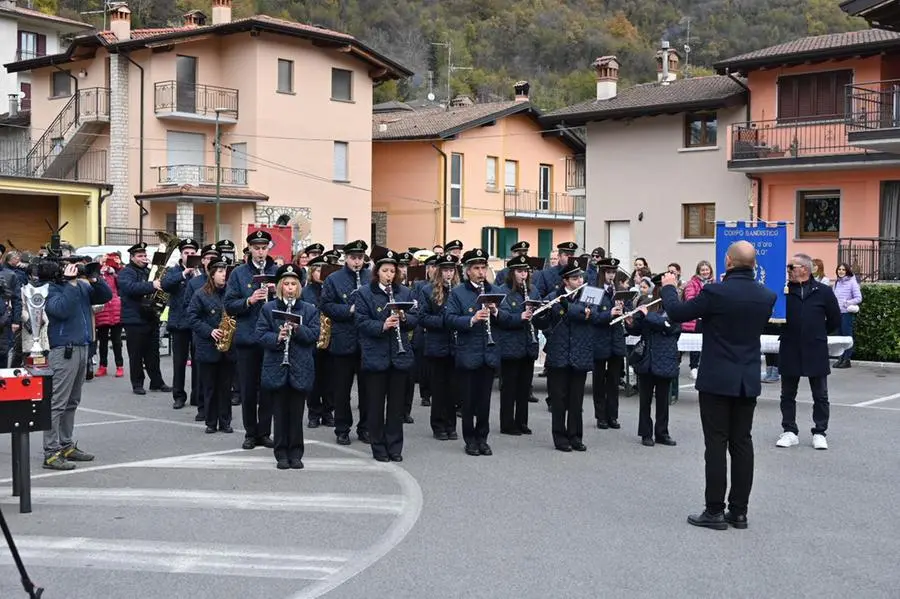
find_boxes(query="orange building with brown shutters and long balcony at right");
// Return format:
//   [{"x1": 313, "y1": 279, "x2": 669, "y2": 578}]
[{"x1": 715, "y1": 29, "x2": 900, "y2": 279}]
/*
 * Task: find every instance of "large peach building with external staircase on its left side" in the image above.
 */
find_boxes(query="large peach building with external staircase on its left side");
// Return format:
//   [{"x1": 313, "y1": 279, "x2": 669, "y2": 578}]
[{"x1": 7, "y1": 0, "x2": 411, "y2": 245}]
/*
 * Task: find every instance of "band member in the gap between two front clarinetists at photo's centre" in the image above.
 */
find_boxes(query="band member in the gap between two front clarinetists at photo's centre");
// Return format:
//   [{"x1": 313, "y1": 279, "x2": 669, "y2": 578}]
[{"x1": 418, "y1": 254, "x2": 459, "y2": 441}]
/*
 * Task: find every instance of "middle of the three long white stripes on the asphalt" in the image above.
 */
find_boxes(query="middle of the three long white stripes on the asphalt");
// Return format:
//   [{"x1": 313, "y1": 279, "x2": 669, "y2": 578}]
[{"x1": 0, "y1": 487, "x2": 406, "y2": 514}]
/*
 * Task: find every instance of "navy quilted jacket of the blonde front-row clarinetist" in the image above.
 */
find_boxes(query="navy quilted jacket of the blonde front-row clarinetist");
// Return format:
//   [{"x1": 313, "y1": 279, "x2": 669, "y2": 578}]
[{"x1": 254, "y1": 299, "x2": 319, "y2": 393}]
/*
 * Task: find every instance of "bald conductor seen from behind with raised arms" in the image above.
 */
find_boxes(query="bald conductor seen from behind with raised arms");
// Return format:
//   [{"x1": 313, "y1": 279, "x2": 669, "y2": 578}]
[{"x1": 661, "y1": 241, "x2": 777, "y2": 530}]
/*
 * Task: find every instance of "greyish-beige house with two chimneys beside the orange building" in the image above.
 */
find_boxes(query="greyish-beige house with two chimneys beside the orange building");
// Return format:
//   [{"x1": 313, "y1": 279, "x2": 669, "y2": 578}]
[{"x1": 545, "y1": 52, "x2": 753, "y2": 275}]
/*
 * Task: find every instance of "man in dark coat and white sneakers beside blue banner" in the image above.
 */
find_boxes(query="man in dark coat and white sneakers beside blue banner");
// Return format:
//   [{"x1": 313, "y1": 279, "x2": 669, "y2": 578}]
[{"x1": 775, "y1": 254, "x2": 841, "y2": 449}]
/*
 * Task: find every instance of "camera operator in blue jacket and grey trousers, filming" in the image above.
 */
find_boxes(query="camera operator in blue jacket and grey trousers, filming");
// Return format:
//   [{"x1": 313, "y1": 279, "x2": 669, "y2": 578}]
[{"x1": 44, "y1": 263, "x2": 112, "y2": 470}]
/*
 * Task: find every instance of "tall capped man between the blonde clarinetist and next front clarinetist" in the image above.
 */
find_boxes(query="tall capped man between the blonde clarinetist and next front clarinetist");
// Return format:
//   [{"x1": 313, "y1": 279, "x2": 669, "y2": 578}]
[{"x1": 320, "y1": 239, "x2": 369, "y2": 445}]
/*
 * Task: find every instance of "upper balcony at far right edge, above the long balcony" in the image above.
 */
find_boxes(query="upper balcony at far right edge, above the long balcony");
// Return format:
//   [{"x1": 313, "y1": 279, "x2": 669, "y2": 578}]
[{"x1": 847, "y1": 79, "x2": 900, "y2": 154}]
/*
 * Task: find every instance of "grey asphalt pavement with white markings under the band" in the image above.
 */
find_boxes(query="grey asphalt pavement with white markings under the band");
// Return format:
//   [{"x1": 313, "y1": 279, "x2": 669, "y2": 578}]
[{"x1": 0, "y1": 357, "x2": 900, "y2": 599}]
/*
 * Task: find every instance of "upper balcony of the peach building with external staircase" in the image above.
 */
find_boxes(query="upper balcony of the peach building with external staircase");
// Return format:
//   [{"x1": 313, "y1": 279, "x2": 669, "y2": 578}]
[{"x1": 153, "y1": 81, "x2": 238, "y2": 125}]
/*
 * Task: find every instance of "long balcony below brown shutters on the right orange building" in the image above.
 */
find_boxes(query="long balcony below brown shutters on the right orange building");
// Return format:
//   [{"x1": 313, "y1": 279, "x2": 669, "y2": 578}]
[{"x1": 728, "y1": 117, "x2": 900, "y2": 173}]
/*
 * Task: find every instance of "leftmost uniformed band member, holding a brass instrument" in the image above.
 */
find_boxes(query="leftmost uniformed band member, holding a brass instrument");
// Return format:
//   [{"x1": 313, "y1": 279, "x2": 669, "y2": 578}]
[{"x1": 116, "y1": 242, "x2": 172, "y2": 395}]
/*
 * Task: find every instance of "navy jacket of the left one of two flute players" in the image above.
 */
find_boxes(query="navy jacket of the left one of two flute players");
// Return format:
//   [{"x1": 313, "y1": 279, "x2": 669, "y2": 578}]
[{"x1": 534, "y1": 290, "x2": 597, "y2": 372}]
